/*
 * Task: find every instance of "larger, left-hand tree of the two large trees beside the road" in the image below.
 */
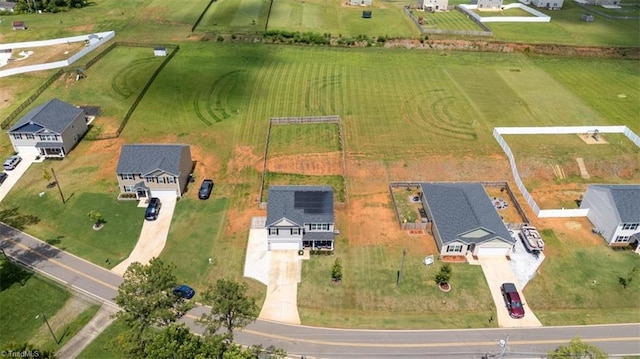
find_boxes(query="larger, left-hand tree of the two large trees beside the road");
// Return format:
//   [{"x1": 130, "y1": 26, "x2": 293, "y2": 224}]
[{"x1": 115, "y1": 258, "x2": 191, "y2": 356}]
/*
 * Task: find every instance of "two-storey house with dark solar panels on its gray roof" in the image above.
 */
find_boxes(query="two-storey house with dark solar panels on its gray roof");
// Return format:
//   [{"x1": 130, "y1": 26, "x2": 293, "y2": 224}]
[{"x1": 265, "y1": 186, "x2": 335, "y2": 250}]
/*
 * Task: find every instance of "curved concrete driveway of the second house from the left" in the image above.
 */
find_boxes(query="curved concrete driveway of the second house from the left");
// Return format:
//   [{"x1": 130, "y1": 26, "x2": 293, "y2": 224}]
[{"x1": 111, "y1": 197, "x2": 176, "y2": 275}]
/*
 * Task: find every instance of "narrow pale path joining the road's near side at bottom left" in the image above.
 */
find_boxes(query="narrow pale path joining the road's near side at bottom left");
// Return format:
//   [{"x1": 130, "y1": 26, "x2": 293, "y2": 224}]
[{"x1": 57, "y1": 303, "x2": 118, "y2": 359}]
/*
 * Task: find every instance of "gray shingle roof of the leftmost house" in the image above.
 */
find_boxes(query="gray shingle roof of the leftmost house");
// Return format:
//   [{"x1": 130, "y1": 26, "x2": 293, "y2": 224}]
[{"x1": 9, "y1": 98, "x2": 84, "y2": 134}]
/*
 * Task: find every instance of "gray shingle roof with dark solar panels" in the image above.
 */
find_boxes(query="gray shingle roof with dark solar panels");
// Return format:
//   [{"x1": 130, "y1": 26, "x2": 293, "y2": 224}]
[{"x1": 266, "y1": 186, "x2": 334, "y2": 227}]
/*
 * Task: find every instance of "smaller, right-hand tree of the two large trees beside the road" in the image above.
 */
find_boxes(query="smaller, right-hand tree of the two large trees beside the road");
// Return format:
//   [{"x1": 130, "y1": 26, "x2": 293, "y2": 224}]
[{"x1": 200, "y1": 279, "x2": 258, "y2": 340}]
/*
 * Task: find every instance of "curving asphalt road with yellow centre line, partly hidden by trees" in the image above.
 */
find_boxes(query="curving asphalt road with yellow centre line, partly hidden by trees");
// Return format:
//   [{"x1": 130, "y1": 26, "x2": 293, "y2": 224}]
[{"x1": 0, "y1": 223, "x2": 640, "y2": 359}]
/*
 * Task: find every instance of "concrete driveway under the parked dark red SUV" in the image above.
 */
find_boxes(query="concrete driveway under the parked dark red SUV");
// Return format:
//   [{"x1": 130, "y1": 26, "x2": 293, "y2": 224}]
[{"x1": 478, "y1": 257, "x2": 542, "y2": 328}]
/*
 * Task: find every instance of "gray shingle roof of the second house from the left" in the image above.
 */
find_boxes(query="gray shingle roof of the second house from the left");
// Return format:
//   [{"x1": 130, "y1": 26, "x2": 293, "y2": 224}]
[{"x1": 116, "y1": 144, "x2": 191, "y2": 177}]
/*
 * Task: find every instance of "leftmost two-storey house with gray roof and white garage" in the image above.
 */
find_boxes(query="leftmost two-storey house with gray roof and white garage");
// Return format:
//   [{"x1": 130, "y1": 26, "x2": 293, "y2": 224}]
[{"x1": 8, "y1": 99, "x2": 89, "y2": 158}]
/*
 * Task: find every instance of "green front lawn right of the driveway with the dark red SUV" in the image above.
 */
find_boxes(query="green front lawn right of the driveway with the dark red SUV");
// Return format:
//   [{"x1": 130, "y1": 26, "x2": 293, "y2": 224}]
[{"x1": 525, "y1": 230, "x2": 640, "y2": 325}]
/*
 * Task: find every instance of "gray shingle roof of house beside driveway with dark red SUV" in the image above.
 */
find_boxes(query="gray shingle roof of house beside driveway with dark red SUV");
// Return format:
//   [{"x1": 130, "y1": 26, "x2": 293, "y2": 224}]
[{"x1": 421, "y1": 183, "x2": 515, "y2": 244}]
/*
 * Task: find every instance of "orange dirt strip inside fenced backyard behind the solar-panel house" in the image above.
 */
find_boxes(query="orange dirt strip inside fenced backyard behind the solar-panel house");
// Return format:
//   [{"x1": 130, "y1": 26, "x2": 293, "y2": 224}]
[{"x1": 258, "y1": 152, "x2": 342, "y2": 176}]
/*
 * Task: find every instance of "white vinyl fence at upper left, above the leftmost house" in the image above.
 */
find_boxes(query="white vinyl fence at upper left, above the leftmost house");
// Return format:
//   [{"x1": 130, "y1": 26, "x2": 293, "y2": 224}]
[{"x1": 0, "y1": 31, "x2": 116, "y2": 77}]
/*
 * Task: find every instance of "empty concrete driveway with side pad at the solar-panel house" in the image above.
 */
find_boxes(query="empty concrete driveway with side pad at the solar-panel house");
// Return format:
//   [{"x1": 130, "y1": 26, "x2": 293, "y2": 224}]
[{"x1": 244, "y1": 217, "x2": 308, "y2": 324}]
